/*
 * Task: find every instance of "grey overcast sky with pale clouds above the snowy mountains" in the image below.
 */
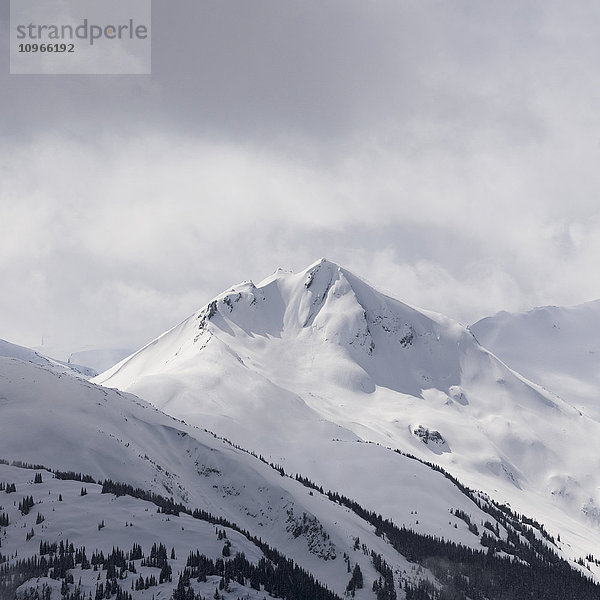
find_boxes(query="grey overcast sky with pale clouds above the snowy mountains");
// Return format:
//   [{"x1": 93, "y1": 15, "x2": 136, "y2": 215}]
[{"x1": 0, "y1": 0, "x2": 600, "y2": 350}]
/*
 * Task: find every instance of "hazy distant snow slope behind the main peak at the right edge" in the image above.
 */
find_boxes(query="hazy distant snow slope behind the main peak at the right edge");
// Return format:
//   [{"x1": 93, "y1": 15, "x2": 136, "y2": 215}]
[{"x1": 471, "y1": 300, "x2": 600, "y2": 420}]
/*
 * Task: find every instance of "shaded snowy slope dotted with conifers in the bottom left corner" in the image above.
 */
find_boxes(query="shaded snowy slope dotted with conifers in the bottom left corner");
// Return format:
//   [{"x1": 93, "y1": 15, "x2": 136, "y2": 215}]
[{"x1": 0, "y1": 465, "x2": 272, "y2": 600}]
